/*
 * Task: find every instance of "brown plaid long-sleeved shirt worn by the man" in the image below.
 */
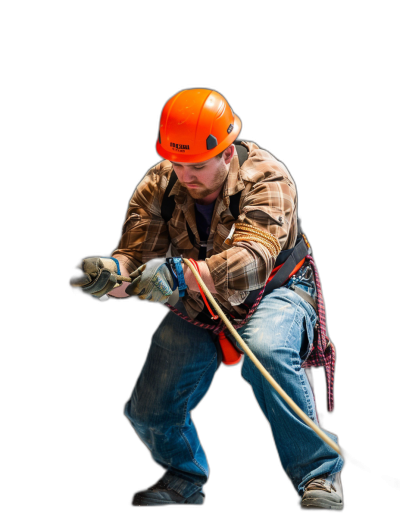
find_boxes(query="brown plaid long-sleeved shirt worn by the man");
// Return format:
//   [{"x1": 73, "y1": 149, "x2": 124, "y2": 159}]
[{"x1": 112, "y1": 141, "x2": 297, "y2": 319}]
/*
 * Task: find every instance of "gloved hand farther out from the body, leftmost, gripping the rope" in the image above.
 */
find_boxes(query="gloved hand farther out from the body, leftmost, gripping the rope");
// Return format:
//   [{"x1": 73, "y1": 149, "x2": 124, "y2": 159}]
[{"x1": 69, "y1": 257, "x2": 122, "y2": 298}]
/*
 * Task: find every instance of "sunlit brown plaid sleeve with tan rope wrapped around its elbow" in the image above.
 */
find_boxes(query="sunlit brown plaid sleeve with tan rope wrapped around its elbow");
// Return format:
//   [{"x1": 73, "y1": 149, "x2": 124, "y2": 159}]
[{"x1": 206, "y1": 172, "x2": 297, "y2": 305}]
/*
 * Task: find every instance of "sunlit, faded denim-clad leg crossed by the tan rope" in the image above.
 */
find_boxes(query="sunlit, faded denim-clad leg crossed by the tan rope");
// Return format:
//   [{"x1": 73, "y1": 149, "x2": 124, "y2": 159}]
[{"x1": 238, "y1": 287, "x2": 344, "y2": 496}]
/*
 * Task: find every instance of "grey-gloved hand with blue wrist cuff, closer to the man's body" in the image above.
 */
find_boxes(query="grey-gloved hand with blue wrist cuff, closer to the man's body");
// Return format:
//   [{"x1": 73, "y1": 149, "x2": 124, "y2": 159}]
[{"x1": 125, "y1": 259, "x2": 179, "y2": 304}]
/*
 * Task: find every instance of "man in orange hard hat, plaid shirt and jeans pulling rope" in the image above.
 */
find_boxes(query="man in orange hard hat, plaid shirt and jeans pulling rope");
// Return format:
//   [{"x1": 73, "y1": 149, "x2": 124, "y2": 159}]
[{"x1": 70, "y1": 89, "x2": 344, "y2": 511}]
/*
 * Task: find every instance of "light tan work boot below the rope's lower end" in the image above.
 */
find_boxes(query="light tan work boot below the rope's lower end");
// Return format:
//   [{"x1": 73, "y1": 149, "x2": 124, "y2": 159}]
[{"x1": 300, "y1": 472, "x2": 344, "y2": 511}]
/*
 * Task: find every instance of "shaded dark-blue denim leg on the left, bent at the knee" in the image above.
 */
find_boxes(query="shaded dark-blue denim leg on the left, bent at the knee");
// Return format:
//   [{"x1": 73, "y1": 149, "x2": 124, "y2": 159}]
[{"x1": 125, "y1": 308, "x2": 217, "y2": 498}]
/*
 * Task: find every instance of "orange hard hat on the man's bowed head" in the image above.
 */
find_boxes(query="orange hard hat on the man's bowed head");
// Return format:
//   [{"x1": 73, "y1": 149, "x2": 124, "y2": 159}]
[{"x1": 156, "y1": 89, "x2": 242, "y2": 162}]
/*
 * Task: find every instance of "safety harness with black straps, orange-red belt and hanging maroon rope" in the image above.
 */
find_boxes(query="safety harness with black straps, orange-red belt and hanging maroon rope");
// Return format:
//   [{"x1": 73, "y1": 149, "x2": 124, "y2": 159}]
[{"x1": 161, "y1": 140, "x2": 336, "y2": 412}]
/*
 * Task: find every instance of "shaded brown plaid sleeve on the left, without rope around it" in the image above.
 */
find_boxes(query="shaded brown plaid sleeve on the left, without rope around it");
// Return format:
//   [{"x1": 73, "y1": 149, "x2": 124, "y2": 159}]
[{"x1": 111, "y1": 161, "x2": 170, "y2": 272}]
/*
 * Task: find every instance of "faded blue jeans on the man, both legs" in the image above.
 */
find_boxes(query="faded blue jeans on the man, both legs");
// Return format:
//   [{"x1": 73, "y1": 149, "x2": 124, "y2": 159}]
[{"x1": 125, "y1": 286, "x2": 344, "y2": 497}]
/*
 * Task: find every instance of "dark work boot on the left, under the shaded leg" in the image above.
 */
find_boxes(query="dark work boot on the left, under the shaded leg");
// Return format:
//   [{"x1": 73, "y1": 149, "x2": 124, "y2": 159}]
[{"x1": 131, "y1": 478, "x2": 206, "y2": 507}]
